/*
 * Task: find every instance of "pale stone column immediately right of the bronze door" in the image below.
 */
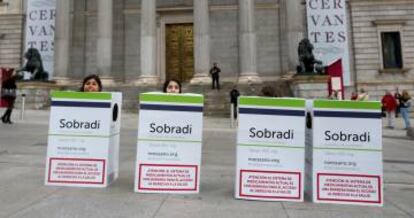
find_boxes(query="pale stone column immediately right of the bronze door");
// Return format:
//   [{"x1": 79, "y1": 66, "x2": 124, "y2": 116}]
[{"x1": 190, "y1": 0, "x2": 211, "y2": 84}]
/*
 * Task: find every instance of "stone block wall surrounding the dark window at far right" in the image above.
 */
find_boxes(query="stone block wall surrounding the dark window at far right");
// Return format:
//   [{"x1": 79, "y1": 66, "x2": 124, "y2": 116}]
[{"x1": 350, "y1": 0, "x2": 414, "y2": 100}]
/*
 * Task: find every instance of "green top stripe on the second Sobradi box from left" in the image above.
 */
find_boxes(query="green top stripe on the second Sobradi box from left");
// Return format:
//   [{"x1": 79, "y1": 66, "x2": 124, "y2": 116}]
[{"x1": 139, "y1": 93, "x2": 204, "y2": 104}]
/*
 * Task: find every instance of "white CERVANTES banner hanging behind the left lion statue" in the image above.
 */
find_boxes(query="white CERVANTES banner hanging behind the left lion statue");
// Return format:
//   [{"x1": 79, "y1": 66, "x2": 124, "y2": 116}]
[{"x1": 24, "y1": 0, "x2": 55, "y2": 79}]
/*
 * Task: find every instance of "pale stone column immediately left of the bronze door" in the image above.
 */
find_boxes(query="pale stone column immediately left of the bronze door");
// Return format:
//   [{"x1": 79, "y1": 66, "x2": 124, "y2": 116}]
[{"x1": 137, "y1": 0, "x2": 160, "y2": 86}]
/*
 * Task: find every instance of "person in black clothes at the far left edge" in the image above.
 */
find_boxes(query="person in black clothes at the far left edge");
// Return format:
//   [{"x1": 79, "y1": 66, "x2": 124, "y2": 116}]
[{"x1": 1, "y1": 74, "x2": 17, "y2": 124}]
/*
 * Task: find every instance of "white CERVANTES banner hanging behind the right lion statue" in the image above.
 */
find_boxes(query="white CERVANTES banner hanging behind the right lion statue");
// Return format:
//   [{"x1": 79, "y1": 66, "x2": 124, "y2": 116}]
[{"x1": 306, "y1": 0, "x2": 351, "y2": 86}]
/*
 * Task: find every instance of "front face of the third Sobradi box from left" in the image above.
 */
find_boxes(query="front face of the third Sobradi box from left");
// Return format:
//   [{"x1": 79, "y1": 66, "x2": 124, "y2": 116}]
[{"x1": 235, "y1": 96, "x2": 305, "y2": 202}]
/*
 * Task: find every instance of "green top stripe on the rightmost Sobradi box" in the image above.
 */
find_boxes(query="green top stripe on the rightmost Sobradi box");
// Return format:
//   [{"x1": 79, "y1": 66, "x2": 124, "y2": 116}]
[{"x1": 313, "y1": 100, "x2": 381, "y2": 110}]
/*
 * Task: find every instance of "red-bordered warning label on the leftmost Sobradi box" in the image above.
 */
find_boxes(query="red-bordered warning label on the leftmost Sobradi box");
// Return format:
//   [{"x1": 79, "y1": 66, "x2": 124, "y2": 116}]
[{"x1": 48, "y1": 158, "x2": 105, "y2": 184}]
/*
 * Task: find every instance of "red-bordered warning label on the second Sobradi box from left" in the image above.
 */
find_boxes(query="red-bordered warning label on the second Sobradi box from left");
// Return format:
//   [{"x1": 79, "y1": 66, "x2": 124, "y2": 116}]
[{"x1": 138, "y1": 164, "x2": 198, "y2": 191}]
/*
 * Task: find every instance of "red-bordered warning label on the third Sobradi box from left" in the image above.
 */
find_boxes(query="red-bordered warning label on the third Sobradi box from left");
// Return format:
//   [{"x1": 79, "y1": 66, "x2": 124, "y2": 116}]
[{"x1": 239, "y1": 170, "x2": 302, "y2": 200}]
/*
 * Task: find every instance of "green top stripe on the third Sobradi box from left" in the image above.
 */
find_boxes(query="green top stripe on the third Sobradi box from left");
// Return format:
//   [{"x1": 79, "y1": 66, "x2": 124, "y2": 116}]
[{"x1": 239, "y1": 96, "x2": 305, "y2": 108}]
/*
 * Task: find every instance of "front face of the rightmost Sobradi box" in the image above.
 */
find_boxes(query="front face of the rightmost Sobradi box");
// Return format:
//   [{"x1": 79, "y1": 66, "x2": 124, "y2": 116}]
[{"x1": 310, "y1": 100, "x2": 384, "y2": 206}]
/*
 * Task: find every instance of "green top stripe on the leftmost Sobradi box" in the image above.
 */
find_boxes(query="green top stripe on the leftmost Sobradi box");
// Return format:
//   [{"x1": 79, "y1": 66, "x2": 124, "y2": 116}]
[{"x1": 52, "y1": 91, "x2": 112, "y2": 100}]
